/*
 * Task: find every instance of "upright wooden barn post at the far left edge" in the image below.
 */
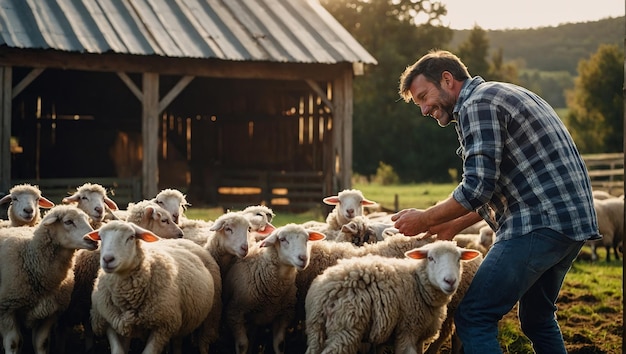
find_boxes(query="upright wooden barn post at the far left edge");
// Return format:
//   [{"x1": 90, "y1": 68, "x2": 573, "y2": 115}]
[{"x1": 0, "y1": 66, "x2": 13, "y2": 193}]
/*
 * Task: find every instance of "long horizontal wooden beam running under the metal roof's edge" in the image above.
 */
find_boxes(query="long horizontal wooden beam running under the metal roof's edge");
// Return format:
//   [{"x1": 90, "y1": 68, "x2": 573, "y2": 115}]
[{"x1": 0, "y1": 47, "x2": 353, "y2": 81}]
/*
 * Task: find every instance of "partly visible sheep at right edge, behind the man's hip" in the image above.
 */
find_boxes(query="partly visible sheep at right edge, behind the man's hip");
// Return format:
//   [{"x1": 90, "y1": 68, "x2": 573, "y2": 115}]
[{"x1": 588, "y1": 198, "x2": 624, "y2": 262}]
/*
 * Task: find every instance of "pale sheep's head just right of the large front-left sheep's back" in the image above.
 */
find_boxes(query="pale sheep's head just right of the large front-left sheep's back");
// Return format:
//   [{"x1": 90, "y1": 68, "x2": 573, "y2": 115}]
[{"x1": 209, "y1": 211, "x2": 253, "y2": 258}]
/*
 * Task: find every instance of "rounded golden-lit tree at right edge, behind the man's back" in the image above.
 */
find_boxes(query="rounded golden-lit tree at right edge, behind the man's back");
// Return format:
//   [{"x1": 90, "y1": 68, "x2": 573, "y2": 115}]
[{"x1": 565, "y1": 44, "x2": 624, "y2": 153}]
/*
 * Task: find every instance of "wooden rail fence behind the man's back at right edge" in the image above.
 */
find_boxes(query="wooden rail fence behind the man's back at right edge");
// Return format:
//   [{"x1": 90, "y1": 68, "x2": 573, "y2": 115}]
[{"x1": 582, "y1": 152, "x2": 624, "y2": 196}]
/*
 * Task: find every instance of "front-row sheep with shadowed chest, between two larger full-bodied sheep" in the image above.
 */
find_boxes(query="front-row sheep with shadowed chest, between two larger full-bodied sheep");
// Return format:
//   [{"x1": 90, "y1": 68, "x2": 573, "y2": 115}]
[{"x1": 223, "y1": 223, "x2": 325, "y2": 354}]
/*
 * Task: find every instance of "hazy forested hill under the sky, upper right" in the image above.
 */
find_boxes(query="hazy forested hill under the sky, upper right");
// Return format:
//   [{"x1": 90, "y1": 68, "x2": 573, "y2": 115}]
[{"x1": 451, "y1": 16, "x2": 625, "y2": 76}]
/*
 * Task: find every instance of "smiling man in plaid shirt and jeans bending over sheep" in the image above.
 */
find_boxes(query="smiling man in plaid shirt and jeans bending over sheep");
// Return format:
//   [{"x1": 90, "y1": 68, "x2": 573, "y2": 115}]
[{"x1": 392, "y1": 50, "x2": 601, "y2": 354}]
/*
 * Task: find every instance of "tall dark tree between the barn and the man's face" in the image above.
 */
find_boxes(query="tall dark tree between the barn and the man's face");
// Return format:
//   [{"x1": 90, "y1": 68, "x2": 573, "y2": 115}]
[{"x1": 321, "y1": 0, "x2": 460, "y2": 182}]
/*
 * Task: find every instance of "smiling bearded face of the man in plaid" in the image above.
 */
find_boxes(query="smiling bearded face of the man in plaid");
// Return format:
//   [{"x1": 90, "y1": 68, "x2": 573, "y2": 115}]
[{"x1": 409, "y1": 75, "x2": 456, "y2": 127}]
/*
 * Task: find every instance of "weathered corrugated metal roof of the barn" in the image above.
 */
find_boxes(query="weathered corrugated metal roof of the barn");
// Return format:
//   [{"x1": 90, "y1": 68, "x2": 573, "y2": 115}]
[{"x1": 0, "y1": 0, "x2": 376, "y2": 64}]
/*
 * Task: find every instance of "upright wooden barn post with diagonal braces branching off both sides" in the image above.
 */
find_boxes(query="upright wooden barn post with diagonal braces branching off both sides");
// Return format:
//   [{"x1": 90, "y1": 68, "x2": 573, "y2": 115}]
[{"x1": 141, "y1": 73, "x2": 159, "y2": 199}]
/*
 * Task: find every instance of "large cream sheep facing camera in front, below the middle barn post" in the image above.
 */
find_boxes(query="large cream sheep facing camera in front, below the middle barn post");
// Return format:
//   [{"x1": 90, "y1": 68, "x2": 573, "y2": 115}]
[{"x1": 88, "y1": 221, "x2": 214, "y2": 353}]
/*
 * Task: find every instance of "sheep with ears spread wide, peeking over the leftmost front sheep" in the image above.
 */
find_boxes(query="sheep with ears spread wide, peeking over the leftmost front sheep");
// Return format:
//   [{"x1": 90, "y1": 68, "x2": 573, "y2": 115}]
[{"x1": 62, "y1": 183, "x2": 119, "y2": 229}]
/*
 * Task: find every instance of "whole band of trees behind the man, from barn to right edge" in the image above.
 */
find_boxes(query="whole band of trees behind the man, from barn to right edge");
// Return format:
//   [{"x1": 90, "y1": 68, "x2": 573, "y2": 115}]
[{"x1": 321, "y1": 0, "x2": 624, "y2": 183}]
